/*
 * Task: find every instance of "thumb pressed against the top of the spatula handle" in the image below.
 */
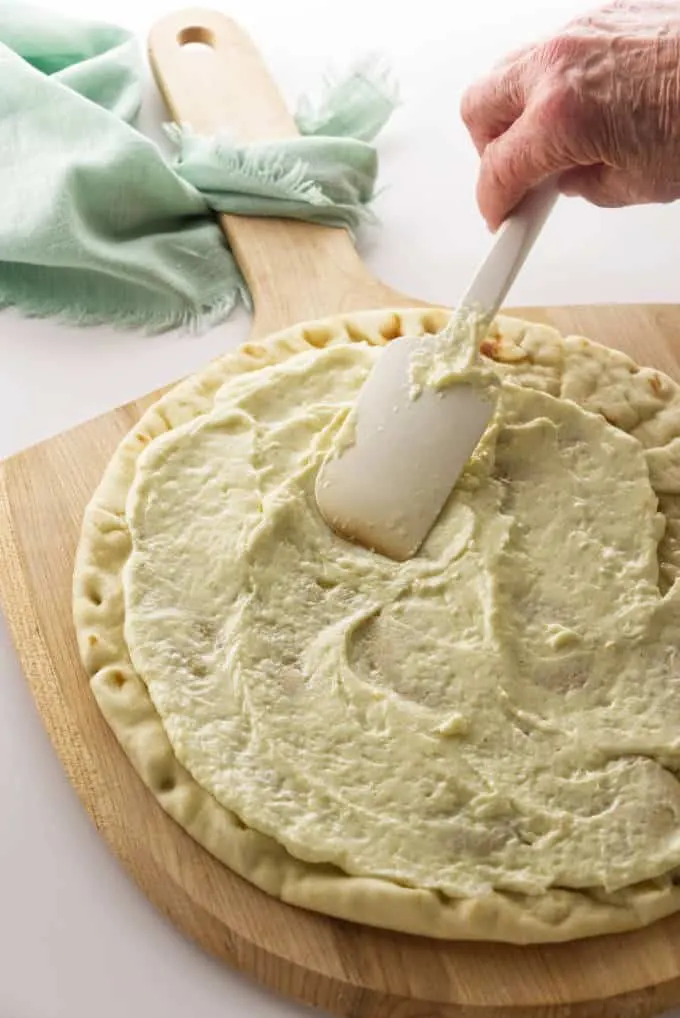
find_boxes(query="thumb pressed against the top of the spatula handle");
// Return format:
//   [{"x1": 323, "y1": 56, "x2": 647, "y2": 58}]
[{"x1": 477, "y1": 109, "x2": 573, "y2": 230}]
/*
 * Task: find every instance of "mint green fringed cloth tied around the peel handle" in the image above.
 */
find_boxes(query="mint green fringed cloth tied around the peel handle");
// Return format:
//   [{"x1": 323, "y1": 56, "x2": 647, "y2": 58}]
[{"x1": 0, "y1": 8, "x2": 396, "y2": 331}]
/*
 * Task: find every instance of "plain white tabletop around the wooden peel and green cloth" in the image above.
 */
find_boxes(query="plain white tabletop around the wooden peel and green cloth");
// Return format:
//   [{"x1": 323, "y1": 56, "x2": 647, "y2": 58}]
[{"x1": 0, "y1": 0, "x2": 680, "y2": 1018}]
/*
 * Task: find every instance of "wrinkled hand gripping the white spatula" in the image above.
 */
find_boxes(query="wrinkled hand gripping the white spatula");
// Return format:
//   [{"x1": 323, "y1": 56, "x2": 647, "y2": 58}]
[{"x1": 461, "y1": 0, "x2": 680, "y2": 229}]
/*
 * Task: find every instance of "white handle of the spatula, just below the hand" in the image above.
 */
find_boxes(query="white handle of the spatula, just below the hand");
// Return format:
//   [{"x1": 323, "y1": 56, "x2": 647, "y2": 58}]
[{"x1": 460, "y1": 178, "x2": 559, "y2": 321}]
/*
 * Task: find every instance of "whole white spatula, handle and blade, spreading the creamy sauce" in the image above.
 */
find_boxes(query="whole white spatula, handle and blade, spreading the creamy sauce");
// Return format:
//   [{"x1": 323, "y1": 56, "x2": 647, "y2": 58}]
[{"x1": 316, "y1": 180, "x2": 558, "y2": 562}]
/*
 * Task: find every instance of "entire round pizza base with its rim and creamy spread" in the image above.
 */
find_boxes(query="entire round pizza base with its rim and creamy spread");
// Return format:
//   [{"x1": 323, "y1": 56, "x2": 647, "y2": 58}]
[{"x1": 74, "y1": 312, "x2": 680, "y2": 942}]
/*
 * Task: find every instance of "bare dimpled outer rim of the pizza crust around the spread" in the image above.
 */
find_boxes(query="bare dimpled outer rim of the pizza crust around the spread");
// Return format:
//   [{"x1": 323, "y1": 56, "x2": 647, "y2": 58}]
[{"x1": 73, "y1": 309, "x2": 680, "y2": 944}]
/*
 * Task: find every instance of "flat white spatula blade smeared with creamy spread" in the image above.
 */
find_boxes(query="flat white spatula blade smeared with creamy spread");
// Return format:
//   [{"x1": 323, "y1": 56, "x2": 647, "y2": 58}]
[{"x1": 316, "y1": 337, "x2": 495, "y2": 562}]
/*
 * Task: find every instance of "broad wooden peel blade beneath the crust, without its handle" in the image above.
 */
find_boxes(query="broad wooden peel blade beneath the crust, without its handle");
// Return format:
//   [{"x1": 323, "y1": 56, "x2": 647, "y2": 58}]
[{"x1": 0, "y1": 306, "x2": 680, "y2": 1018}]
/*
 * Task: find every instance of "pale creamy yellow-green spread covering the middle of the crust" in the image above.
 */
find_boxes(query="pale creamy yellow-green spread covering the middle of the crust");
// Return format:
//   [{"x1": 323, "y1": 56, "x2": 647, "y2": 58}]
[{"x1": 124, "y1": 335, "x2": 680, "y2": 896}]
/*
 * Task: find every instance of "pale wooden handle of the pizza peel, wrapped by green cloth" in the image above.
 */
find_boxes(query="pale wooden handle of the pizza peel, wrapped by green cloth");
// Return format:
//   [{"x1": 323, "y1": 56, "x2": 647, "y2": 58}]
[{"x1": 149, "y1": 8, "x2": 405, "y2": 335}]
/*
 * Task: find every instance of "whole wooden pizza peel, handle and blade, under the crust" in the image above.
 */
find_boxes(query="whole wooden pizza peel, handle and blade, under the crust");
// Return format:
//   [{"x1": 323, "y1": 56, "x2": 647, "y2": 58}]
[{"x1": 0, "y1": 11, "x2": 680, "y2": 1018}]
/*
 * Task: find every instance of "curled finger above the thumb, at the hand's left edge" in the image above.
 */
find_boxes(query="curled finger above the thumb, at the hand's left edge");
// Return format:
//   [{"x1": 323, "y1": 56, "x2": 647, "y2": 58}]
[{"x1": 460, "y1": 64, "x2": 524, "y2": 155}]
